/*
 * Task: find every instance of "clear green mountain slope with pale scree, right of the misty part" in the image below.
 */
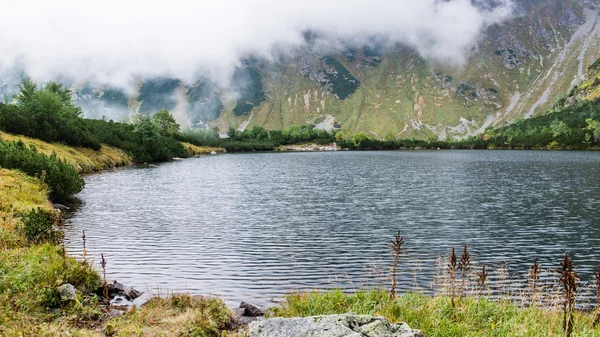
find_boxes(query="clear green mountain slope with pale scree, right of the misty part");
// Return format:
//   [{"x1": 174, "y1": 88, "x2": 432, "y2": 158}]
[{"x1": 231, "y1": 1, "x2": 600, "y2": 139}]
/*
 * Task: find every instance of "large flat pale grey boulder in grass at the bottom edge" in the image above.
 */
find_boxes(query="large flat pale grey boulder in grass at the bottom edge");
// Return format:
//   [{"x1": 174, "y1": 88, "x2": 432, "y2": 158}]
[{"x1": 250, "y1": 313, "x2": 425, "y2": 337}]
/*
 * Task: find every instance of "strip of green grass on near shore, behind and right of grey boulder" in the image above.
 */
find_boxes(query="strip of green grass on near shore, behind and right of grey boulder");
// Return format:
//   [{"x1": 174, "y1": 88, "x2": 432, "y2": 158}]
[{"x1": 269, "y1": 290, "x2": 600, "y2": 337}]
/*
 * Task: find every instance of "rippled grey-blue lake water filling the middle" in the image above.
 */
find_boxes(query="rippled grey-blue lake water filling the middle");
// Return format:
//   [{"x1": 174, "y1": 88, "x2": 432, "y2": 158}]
[{"x1": 66, "y1": 151, "x2": 600, "y2": 305}]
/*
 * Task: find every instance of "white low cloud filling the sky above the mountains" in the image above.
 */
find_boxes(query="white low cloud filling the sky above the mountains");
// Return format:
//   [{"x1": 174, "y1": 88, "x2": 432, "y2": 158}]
[{"x1": 0, "y1": 0, "x2": 512, "y2": 86}]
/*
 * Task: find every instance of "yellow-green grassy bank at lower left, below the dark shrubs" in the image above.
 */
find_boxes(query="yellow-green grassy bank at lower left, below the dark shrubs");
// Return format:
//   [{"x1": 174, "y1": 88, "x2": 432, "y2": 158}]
[{"x1": 0, "y1": 169, "x2": 231, "y2": 336}]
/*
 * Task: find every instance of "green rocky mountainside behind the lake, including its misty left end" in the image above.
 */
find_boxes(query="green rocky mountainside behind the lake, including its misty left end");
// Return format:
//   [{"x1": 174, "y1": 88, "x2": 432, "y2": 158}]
[{"x1": 0, "y1": 0, "x2": 600, "y2": 139}]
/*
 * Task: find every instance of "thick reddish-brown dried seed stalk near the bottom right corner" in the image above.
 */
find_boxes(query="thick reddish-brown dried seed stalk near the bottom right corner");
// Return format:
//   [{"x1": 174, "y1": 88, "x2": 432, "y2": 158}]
[{"x1": 557, "y1": 254, "x2": 579, "y2": 337}]
